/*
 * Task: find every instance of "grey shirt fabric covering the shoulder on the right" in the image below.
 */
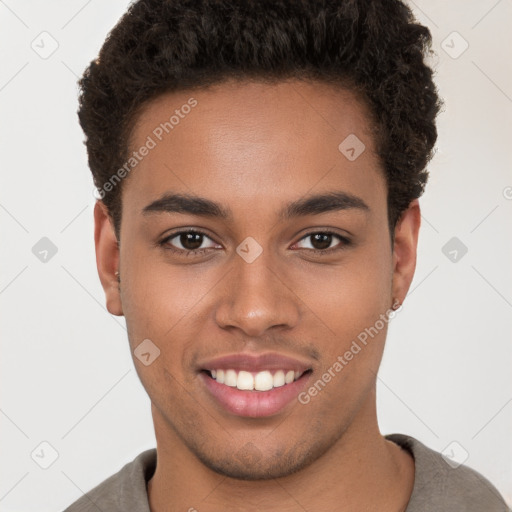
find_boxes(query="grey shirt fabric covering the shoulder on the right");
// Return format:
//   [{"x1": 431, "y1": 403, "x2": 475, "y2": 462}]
[{"x1": 385, "y1": 434, "x2": 510, "y2": 512}]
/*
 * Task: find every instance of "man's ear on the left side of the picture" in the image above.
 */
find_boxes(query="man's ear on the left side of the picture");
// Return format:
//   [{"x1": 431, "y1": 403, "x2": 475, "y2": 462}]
[{"x1": 94, "y1": 200, "x2": 123, "y2": 316}]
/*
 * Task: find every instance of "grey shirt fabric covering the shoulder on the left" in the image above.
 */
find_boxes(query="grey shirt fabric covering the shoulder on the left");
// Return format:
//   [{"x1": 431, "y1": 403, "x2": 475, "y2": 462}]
[{"x1": 64, "y1": 448, "x2": 156, "y2": 512}]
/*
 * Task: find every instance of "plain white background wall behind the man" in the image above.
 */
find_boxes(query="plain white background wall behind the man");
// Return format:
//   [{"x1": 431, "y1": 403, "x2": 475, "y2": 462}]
[{"x1": 0, "y1": 0, "x2": 512, "y2": 512}]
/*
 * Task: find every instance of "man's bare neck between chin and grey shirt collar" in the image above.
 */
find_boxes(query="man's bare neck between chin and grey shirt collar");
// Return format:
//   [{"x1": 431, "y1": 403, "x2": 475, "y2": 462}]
[{"x1": 148, "y1": 393, "x2": 414, "y2": 512}]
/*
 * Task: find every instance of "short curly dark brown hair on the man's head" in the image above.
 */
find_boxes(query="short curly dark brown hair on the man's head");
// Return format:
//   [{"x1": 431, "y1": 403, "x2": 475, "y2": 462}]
[{"x1": 78, "y1": 0, "x2": 442, "y2": 239}]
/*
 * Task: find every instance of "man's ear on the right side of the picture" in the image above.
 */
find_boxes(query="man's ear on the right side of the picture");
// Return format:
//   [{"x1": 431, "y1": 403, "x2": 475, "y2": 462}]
[{"x1": 393, "y1": 199, "x2": 421, "y2": 304}]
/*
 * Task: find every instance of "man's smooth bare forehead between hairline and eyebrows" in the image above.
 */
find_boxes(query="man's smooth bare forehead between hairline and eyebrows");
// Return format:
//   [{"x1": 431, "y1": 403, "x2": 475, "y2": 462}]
[{"x1": 123, "y1": 81, "x2": 384, "y2": 219}]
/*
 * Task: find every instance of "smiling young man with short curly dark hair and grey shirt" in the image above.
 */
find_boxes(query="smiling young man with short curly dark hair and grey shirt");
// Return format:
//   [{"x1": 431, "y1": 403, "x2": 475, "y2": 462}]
[{"x1": 67, "y1": 0, "x2": 507, "y2": 512}]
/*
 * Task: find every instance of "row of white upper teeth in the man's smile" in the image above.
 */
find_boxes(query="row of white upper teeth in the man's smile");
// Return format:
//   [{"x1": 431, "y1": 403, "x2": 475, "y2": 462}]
[{"x1": 210, "y1": 370, "x2": 302, "y2": 391}]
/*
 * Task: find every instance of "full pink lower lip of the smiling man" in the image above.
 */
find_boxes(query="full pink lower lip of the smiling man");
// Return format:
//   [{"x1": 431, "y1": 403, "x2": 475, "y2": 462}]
[{"x1": 200, "y1": 372, "x2": 310, "y2": 418}]
